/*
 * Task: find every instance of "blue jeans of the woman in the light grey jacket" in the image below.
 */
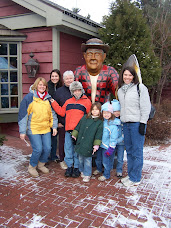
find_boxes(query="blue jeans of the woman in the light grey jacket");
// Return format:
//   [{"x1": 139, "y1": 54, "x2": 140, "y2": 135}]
[{"x1": 123, "y1": 122, "x2": 145, "y2": 182}]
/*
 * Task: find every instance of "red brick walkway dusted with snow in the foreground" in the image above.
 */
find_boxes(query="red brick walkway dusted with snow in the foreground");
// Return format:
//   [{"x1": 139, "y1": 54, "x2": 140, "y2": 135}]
[{"x1": 0, "y1": 136, "x2": 171, "y2": 228}]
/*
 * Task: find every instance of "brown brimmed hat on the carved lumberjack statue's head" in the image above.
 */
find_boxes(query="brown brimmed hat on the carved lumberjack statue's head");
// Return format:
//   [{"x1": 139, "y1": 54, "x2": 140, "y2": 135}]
[{"x1": 81, "y1": 38, "x2": 109, "y2": 53}]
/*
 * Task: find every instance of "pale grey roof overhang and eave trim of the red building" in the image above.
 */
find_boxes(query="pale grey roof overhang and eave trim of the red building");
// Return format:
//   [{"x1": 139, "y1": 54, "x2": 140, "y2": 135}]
[{"x1": 0, "y1": 0, "x2": 102, "y2": 36}]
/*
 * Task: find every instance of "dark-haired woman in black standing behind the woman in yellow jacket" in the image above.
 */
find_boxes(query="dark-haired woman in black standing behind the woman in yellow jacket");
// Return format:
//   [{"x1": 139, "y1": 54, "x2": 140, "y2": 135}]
[{"x1": 48, "y1": 69, "x2": 62, "y2": 162}]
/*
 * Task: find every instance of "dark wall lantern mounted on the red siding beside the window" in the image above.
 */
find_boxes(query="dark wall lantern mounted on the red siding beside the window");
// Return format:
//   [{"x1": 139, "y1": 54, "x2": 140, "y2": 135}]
[{"x1": 25, "y1": 52, "x2": 39, "y2": 78}]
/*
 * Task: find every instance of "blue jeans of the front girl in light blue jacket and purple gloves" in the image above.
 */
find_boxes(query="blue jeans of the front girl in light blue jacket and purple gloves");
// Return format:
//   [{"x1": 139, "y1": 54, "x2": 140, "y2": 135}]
[{"x1": 96, "y1": 147, "x2": 115, "y2": 179}]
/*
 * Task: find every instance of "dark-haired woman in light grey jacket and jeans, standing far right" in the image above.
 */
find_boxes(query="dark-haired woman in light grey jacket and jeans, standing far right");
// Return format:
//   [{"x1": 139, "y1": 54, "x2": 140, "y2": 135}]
[{"x1": 118, "y1": 67, "x2": 151, "y2": 187}]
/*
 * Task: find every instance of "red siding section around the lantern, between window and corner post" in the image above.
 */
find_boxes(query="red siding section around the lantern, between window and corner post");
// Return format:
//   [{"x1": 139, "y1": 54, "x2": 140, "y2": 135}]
[{"x1": 20, "y1": 27, "x2": 52, "y2": 96}]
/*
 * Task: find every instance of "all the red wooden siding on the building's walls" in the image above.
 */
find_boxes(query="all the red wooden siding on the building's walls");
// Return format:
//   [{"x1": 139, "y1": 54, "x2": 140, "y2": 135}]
[{"x1": 0, "y1": 0, "x2": 89, "y2": 137}]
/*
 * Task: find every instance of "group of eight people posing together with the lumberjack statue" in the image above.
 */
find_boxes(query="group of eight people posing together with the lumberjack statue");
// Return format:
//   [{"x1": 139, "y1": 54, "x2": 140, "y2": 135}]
[{"x1": 18, "y1": 38, "x2": 151, "y2": 187}]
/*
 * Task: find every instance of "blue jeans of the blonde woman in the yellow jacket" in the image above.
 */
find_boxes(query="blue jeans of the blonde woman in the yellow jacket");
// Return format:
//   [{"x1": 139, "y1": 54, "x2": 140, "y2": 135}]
[{"x1": 28, "y1": 132, "x2": 51, "y2": 167}]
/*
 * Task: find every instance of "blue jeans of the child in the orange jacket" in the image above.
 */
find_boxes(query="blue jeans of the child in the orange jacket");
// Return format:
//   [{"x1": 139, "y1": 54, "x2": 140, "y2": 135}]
[{"x1": 64, "y1": 131, "x2": 79, "y2": 168}]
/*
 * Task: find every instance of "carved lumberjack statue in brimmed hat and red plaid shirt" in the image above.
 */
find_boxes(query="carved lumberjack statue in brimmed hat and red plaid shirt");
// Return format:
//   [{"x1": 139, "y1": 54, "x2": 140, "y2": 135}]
[{"x1": 75, "y1": 38, "x2": 118, "y2": 104}]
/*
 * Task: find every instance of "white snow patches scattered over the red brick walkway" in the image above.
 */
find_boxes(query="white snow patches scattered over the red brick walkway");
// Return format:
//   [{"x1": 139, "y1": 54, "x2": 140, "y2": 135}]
[{"x1": 0, "y1": 145, "x2": 171, "y2": 228}]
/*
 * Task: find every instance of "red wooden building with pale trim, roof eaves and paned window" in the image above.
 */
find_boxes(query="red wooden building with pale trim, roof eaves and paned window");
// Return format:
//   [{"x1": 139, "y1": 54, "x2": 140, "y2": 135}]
[{"x1": 0, "y1": 0, "x2": 100, "y2": 136}]
